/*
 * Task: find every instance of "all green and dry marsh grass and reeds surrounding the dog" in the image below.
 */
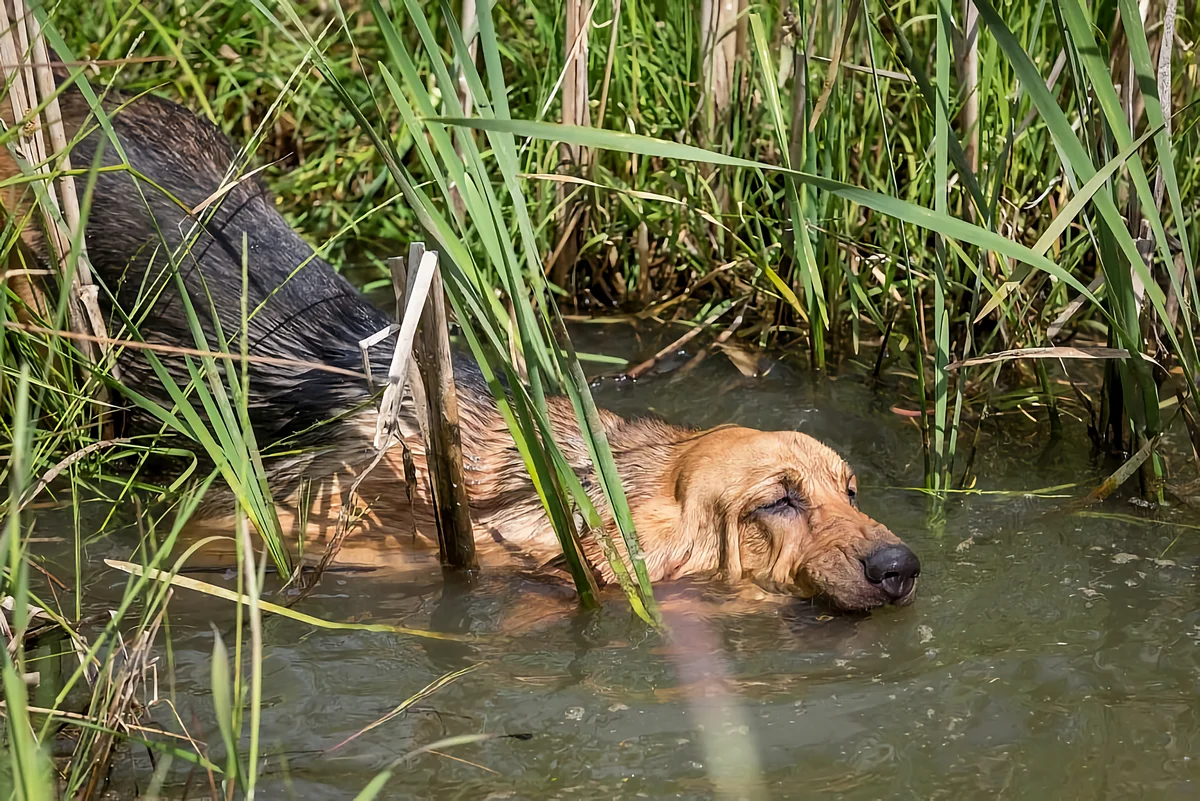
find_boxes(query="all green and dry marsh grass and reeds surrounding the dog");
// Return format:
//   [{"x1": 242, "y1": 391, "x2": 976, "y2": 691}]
[{"x1": 0, "y1": 0, "x2": 1200, "y2": 799}]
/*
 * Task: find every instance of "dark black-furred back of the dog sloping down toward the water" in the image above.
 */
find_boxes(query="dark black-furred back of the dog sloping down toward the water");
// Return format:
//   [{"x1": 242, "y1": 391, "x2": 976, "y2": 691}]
[{"x1": 0, "y1": 74, "x2": 389, "y2": 435}]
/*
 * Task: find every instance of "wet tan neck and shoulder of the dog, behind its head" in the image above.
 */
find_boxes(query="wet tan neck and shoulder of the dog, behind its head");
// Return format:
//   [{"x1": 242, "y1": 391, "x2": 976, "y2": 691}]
[{"x1": 274, "y1": 376, "x2": 721, "y2": 583}]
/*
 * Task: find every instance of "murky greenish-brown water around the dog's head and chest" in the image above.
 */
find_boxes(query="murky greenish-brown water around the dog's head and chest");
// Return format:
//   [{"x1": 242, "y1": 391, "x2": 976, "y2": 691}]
[{"x1": 77, "y1": 329, "x2": 1200, "y2": 800}]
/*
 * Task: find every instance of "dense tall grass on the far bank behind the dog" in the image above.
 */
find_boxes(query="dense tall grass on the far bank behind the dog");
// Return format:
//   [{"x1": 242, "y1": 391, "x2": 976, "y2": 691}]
[{"x1": 54, "y1": 0, "x2": 1200, "y2": 496}]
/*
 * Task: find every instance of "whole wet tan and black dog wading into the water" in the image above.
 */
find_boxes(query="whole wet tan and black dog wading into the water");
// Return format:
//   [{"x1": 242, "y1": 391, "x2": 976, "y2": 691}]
[{"x1": 0, "y1": 70, "x2": 919, "y2": 609}]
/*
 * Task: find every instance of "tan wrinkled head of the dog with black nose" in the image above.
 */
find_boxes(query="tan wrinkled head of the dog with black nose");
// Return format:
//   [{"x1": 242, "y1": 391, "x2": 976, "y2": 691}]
[{"x1": 665, "y1": 428, "x2": 920, "y2": 609}]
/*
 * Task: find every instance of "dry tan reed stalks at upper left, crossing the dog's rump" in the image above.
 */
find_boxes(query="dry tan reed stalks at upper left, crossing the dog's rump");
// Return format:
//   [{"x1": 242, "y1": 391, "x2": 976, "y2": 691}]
[{"x1": 0, "y1": 0, "x2": 119, "y2": 390}]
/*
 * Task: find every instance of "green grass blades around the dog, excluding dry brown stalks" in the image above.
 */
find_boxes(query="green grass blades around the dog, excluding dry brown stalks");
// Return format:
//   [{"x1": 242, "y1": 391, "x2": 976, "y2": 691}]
[{"x1": 0, "y1": 0, "x2": 1200, "y2": 797}]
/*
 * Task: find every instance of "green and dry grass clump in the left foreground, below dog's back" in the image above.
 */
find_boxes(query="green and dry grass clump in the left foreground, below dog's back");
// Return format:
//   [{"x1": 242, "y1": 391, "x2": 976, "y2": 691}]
[{"x1": 0, "y1": 10, "x2": 484, "y2": 799}]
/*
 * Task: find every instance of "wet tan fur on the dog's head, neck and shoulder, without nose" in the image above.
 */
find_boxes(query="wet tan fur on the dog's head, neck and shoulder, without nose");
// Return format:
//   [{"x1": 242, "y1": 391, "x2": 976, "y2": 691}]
[{"x1": 187, "y1": 388, "x2": 900, "y2": 608}]
